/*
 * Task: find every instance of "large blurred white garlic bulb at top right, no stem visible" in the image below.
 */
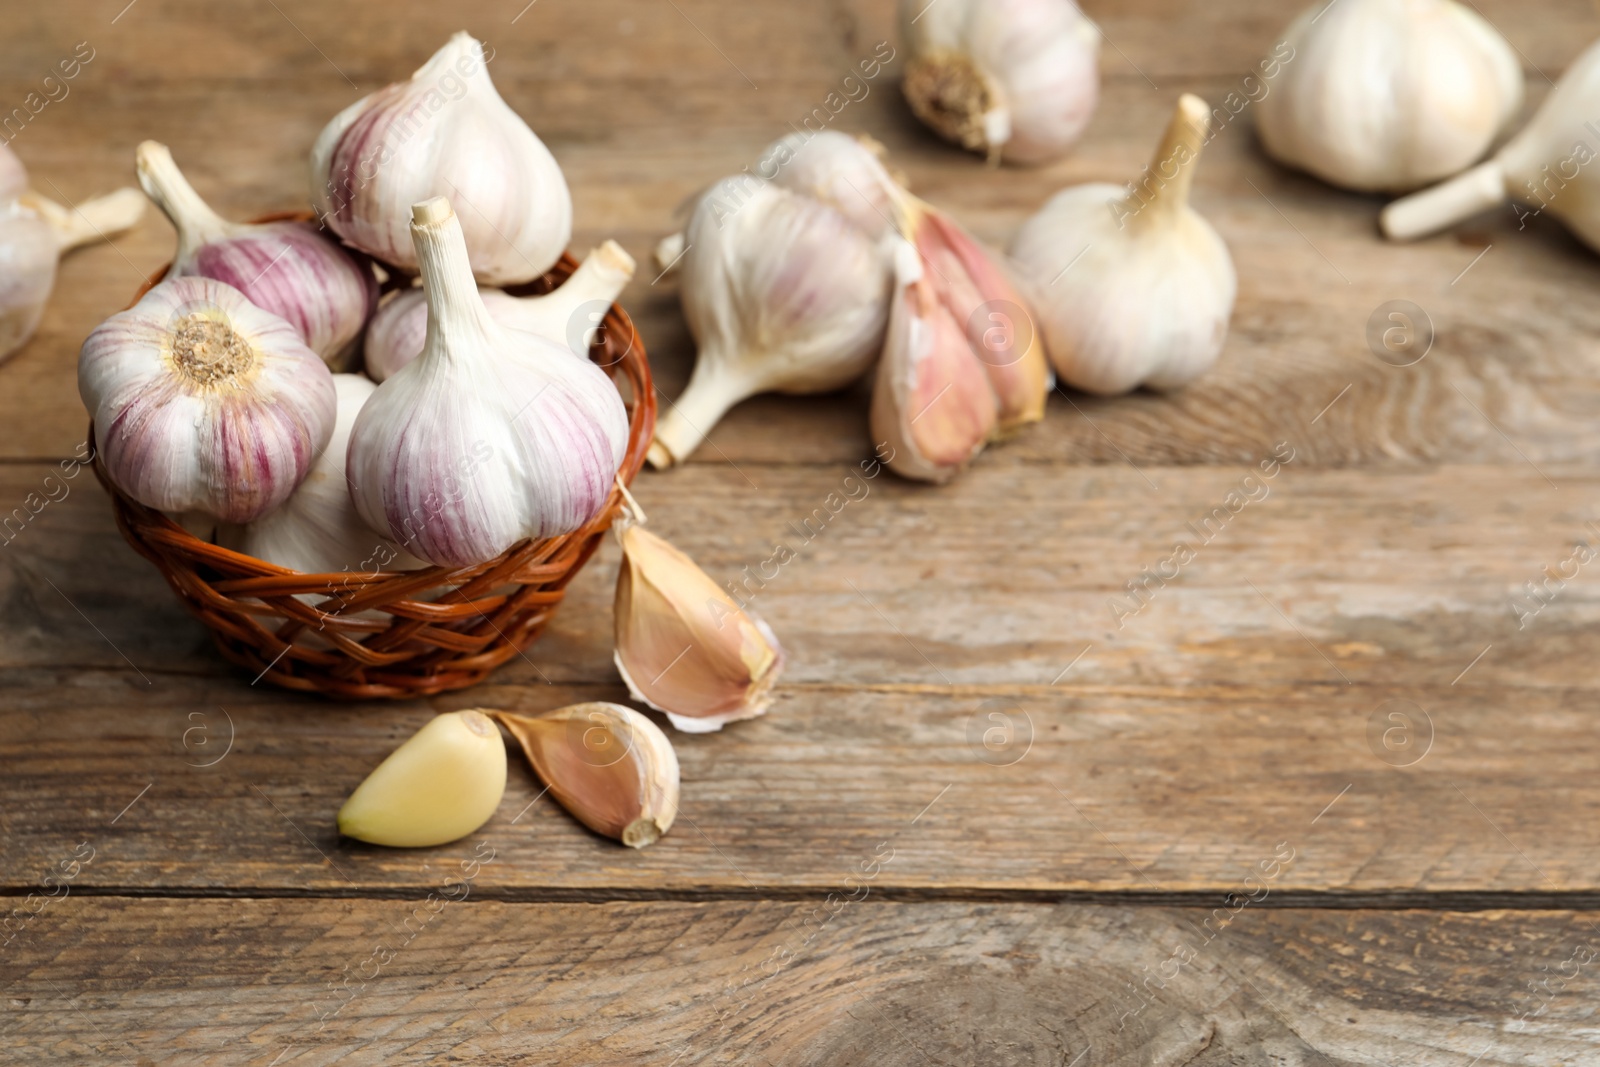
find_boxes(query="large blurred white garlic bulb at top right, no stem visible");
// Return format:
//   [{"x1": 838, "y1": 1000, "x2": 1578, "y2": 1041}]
[{"x1": 1256, "y1": 0, "x2": 1522, "y2": 192}]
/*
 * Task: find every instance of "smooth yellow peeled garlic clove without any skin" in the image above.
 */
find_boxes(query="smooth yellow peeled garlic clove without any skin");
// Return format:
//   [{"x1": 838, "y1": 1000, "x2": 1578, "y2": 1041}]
[{"x1": 339, "y1": 710, "x2": 506, "y2": 848}]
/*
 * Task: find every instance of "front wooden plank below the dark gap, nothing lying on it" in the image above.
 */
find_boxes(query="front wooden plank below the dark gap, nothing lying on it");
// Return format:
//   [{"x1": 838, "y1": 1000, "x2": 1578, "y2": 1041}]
[{"x1": 0, "y1": 895, "x2": 1600, "y2": 1067}]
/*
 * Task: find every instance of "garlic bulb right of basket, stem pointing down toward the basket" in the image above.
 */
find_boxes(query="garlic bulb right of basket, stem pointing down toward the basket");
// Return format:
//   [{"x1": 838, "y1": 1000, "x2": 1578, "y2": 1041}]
[{"x1": 648, "y1": 174, "x2": 890, "y2": 467}]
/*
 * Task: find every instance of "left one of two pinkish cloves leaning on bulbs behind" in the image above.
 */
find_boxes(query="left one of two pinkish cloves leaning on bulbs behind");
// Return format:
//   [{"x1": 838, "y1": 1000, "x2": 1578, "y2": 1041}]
[{"x1": 872, "y1": 243, "x2": 1000, "y2": 483}]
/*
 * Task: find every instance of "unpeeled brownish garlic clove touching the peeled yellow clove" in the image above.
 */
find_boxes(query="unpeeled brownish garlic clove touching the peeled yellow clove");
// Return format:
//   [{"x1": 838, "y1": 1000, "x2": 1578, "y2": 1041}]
[{"x1": 494, "y1": 702, "x2": 678, "y2": 848}]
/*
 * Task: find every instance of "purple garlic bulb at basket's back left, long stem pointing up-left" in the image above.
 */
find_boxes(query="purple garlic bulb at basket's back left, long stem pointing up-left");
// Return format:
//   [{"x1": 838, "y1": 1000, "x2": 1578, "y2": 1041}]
[{"x1": 136, "y1": 141, "x2": 378, "y2": 370}]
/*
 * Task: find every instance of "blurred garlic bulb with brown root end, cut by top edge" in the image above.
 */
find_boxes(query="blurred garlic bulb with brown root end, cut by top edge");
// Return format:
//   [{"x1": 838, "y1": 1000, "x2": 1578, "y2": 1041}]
[{"x1": 899, "y1": 0, "x2": 1099, "y2": 163}]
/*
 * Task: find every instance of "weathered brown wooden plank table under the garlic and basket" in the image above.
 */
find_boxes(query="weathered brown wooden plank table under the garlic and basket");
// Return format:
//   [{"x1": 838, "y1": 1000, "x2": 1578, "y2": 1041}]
[{"x1": 0, "y1": 0, "x2": 1600, "y2": 1067}]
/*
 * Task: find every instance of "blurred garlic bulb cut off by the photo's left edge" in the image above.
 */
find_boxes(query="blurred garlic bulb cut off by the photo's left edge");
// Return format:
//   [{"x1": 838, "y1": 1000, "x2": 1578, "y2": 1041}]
[{"x1": 0, "y1": 144, "x2": 144, "y2": 360}]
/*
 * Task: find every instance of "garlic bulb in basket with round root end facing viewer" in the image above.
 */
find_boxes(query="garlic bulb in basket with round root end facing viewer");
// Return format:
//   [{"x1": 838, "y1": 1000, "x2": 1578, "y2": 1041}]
[{"x1": 78, "y1": 277, "x2": 338, "y2": 523}]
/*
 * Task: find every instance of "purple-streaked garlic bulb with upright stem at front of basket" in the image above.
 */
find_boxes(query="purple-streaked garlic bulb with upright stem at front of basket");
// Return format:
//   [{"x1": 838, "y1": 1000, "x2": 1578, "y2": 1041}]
[{"x1": 346, "y1": 197, "x2": 629, "y2": 566}]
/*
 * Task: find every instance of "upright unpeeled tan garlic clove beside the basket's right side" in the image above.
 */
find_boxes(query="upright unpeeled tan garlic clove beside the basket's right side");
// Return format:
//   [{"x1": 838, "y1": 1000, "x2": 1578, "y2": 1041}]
[{"x1": 613, "y1": 517, "x2": 784, "y2": 734}]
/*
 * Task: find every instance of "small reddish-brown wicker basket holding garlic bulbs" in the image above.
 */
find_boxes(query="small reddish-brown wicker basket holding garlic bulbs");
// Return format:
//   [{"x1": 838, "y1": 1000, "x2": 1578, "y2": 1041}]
[{"x1": 90, "y1": 222, "x2": 656, "y2": 699}]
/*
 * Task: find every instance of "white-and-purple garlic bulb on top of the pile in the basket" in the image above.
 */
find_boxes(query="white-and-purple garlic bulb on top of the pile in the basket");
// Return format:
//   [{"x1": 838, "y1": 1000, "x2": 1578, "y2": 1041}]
[{"x1": 310, "y1": 32, "x2": 573, "y2": 285}]
